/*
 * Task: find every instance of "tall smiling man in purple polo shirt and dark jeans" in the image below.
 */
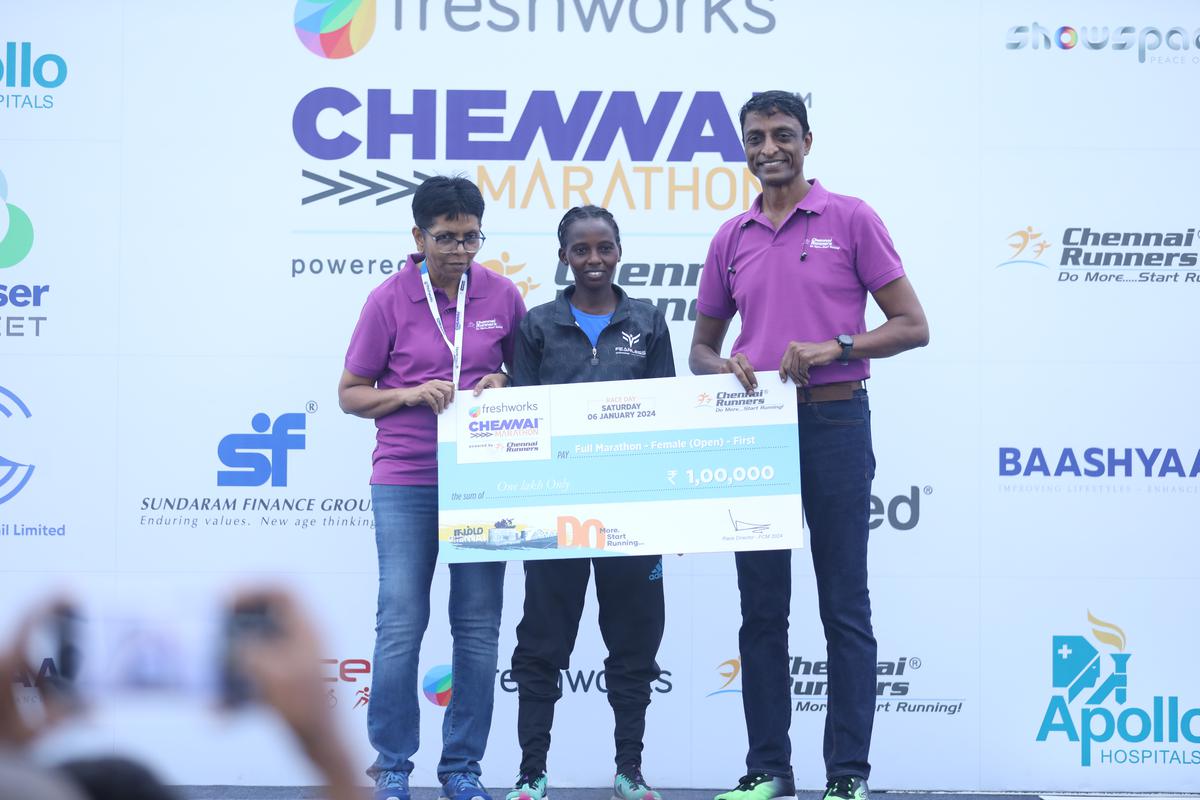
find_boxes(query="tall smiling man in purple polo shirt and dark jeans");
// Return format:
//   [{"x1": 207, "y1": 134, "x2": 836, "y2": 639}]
[{"x1": 689, "y1": 91, "x2": 929, "y2": 800}]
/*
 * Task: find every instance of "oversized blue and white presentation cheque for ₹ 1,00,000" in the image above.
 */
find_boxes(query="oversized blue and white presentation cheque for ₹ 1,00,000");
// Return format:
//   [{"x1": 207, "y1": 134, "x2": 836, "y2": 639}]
[{"x1": 438, "y1": 374, "x2": 804, "y2": 563}]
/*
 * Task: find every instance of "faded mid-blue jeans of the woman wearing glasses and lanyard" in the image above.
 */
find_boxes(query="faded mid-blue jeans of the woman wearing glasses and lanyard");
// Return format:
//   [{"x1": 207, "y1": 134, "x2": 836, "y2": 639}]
[{"x1": 367, "y1": 486, "x2": 504, "y2": 777}]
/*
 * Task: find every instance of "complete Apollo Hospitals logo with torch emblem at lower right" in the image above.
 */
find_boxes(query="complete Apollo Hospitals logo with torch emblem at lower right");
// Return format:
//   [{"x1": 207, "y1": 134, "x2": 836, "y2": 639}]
[{"x1": 1037, "y1": 612, "x2": 1200, "y2": 766}]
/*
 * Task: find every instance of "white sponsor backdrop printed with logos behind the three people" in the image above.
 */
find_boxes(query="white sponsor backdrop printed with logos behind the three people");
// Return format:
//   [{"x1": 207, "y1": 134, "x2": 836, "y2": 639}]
[{"x1": 0, "y1": 0, "x2": 1200, "y2": 790}]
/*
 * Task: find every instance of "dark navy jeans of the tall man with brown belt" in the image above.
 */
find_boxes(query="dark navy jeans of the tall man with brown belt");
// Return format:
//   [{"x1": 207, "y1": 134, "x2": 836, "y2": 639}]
[{"x1": 736, "y1": 390, "x2": 876, "y2": 778}]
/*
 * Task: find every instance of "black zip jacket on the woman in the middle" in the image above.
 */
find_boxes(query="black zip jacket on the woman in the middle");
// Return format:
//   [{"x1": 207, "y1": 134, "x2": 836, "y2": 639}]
[{"x1": 511, "y1": 284, "x2": 674, "y2": 386}]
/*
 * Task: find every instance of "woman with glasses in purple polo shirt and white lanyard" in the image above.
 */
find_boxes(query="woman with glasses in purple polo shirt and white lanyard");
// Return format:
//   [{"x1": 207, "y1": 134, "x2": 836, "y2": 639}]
[{"x1": 337, "y1": 176, "x2": 526, "y2": 800}]
